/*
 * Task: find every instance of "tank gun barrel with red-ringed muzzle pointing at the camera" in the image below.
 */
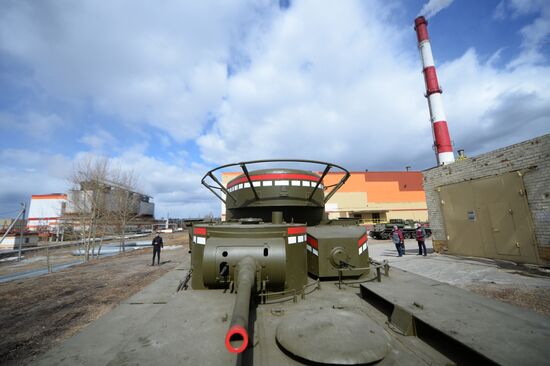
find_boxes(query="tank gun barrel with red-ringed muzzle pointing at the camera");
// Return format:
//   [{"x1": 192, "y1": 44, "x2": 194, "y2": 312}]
[{"x1": 225, "y1": 257, "x2": 256, "y2": 353}]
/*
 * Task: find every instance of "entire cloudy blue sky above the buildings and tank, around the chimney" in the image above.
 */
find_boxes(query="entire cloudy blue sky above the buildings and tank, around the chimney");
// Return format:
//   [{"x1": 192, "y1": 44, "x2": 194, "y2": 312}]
[{"x1": 0, "y1": 0, "x2": 550, "y2": 217}]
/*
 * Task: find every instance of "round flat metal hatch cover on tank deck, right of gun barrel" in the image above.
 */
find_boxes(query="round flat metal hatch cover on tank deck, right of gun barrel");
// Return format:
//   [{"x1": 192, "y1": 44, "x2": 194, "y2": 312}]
[{"x1": 276, "y1": 309, "x2": 390, "y2": 365}]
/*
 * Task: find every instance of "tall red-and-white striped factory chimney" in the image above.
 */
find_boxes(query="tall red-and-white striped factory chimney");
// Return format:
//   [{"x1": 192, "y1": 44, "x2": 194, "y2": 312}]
[{"x1": 414, "y1": 17, "x2": 455, "y2": 165}]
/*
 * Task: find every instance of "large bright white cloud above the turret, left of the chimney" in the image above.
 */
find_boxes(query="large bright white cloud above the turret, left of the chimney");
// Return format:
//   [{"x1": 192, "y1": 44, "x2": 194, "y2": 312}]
[{"x1": 198, "y1": 1, "x2": 430, "y2": 168}]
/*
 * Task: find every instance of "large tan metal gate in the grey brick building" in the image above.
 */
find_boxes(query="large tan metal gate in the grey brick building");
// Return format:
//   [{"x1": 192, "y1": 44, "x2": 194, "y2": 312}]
[{"x1": 439, "y1": 172, "x2": 539, "y2": 263}]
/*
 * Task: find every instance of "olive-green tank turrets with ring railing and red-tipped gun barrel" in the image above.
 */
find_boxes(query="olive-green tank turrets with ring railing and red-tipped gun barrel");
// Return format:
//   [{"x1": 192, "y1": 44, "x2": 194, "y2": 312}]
[{"x1": 193, "y1": 159, "x2": 369, "y2": 353}]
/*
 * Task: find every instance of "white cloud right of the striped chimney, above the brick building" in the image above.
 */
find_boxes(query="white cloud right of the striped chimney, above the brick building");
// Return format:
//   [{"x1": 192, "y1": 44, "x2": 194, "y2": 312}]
[{"x1": 439, "y1": 49, "x2": 550, "y2": 154}]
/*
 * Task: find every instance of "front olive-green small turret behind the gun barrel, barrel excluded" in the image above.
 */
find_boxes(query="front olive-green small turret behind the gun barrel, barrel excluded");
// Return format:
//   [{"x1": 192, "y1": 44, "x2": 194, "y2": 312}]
[{"x1": 191, "y1": 223, "x2": 307, "y2": 291}]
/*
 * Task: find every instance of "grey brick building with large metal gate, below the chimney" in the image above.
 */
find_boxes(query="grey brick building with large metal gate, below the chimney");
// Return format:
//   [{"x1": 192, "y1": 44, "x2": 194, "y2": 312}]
[{"x1": 423, "y1": 134, "x2": 550, "y2": 265}]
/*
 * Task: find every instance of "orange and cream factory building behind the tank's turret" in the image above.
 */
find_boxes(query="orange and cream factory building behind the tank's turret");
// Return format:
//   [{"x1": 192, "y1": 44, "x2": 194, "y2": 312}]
[{"x1": 221, "y1": 171, "x2": 428, "y2": 225}]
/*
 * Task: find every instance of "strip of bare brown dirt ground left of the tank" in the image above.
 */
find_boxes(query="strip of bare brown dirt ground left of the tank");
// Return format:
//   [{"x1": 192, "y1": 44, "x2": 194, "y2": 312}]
[{"x1": 0, "y1": 233, "x2": 188, "y2": 365}]
